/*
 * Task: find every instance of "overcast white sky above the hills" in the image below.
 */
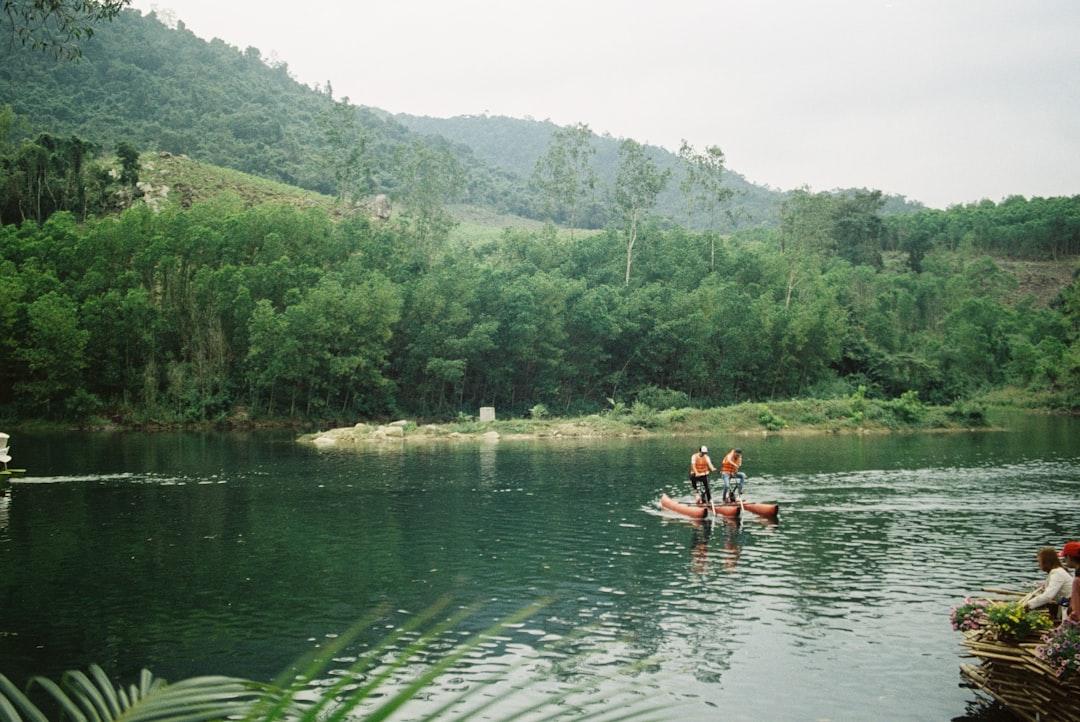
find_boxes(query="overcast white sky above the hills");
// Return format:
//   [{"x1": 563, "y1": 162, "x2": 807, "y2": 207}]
[{"x1": 133, "y1": 0, "x2": 1080, "y2": 208}]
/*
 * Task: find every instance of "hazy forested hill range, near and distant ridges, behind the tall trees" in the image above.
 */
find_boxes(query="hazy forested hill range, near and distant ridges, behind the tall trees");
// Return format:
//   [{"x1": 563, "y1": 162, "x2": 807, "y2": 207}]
[{"x1": 0, "y1": 5, "x2": 920, "y2": 231}]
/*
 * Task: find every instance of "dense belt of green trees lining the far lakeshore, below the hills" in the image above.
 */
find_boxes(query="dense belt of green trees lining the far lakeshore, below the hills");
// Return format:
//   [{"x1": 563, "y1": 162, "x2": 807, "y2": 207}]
[{"x1": 0, "y1": 188, "x2": 1080, "y2": 430}]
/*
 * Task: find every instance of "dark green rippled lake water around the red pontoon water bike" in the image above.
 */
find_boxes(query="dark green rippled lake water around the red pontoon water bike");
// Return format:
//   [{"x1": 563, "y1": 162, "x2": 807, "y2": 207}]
[{"x1": 0, "y1": 416, "x2": 1080, "y2": 721}]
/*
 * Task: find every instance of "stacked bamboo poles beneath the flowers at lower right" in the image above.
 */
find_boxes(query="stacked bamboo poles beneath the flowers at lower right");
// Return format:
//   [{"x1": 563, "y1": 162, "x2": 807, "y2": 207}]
[{"x1": 960, "y1": 589, "x2": 1080, "y2": 722}]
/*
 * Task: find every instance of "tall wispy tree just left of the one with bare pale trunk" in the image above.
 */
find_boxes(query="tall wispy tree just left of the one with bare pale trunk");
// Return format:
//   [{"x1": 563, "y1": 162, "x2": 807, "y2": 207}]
[{"x1": 531, "y1": 123, "x2": 596, "y2": 241}]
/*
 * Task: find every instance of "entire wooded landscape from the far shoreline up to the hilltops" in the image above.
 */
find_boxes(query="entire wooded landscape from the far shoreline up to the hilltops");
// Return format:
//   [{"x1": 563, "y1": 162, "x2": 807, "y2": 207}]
[{"x1": 0, "y1": 12, "x2": 1080, "y2": 423}]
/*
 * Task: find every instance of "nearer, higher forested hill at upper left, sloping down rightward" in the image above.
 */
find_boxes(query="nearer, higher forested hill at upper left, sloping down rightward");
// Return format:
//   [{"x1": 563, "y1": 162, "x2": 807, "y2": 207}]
[{"x1": 0, "y1": 11, "x2": 530, "y2": 214}]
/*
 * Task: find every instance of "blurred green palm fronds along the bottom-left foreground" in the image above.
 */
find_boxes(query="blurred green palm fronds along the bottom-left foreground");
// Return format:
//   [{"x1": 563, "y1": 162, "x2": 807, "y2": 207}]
[{"x1": 0, "y1": 598, "x2": 672, "y2": 722}]
